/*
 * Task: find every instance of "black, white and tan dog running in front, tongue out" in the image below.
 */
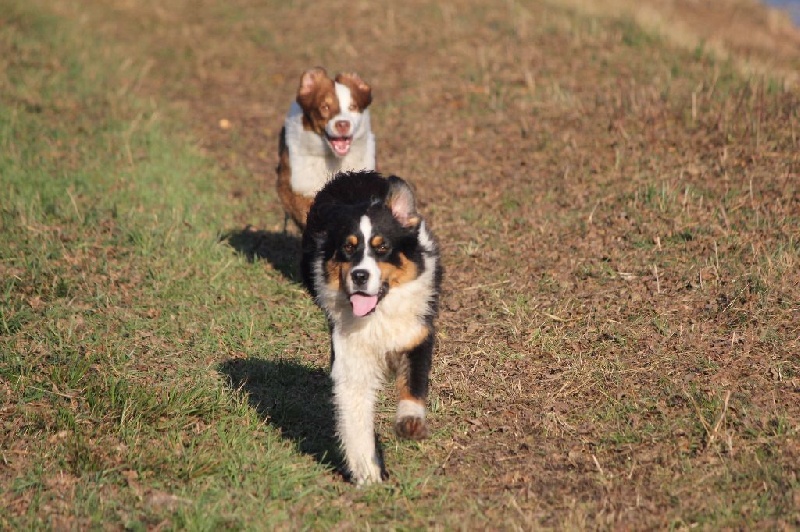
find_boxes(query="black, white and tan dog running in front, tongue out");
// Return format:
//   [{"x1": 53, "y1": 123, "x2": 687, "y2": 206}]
[{"x1": 301, "y1": 172, "x2": 442, "y2": 485}]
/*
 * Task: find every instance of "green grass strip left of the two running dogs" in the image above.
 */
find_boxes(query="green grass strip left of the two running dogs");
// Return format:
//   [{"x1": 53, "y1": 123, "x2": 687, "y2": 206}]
[{"x1": 0, "y1": 5, "x2": 335, "y2": 528}]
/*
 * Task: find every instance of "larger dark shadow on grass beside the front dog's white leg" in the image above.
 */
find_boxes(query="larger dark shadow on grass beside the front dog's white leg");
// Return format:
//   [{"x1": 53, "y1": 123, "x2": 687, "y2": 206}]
[{"x1": 218, "y1": 358, "x2": 341, "y2": 471}]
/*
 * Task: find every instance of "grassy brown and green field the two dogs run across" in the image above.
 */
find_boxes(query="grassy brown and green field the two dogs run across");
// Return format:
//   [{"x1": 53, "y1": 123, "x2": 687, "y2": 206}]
[{"x1": 0, "y1": 0, "x2": 800, "y2": 530}]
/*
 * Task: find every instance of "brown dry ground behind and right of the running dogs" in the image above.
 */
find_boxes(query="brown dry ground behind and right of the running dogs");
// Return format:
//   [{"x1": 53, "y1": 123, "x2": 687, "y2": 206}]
[{"x1": 47, "y1": 1, "x2": 800, "y2": 527}]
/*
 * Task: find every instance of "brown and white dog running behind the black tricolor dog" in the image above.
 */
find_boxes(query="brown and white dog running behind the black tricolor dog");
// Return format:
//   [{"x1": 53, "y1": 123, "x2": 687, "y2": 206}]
[{"x1": 277, "y1": 67, "x2": 375, "y2": 230}]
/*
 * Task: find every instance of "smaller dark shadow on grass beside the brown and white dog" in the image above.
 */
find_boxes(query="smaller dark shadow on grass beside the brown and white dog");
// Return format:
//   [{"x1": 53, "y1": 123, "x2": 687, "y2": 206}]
[{"x1": 220, "y1": 225, "x2": 300, "y2": 282}]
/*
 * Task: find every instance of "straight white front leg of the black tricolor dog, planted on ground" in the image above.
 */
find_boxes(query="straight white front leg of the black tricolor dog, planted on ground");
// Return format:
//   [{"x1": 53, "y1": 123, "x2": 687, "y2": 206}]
[{"x1": 331, "y1": 334, "x2": 383, "y2": 486}]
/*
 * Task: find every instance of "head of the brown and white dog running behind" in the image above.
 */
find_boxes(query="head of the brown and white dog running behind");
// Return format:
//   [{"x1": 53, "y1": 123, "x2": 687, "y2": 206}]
[{"x1": 297, "y1": 68, "x2": 372, "y2": 157}]
